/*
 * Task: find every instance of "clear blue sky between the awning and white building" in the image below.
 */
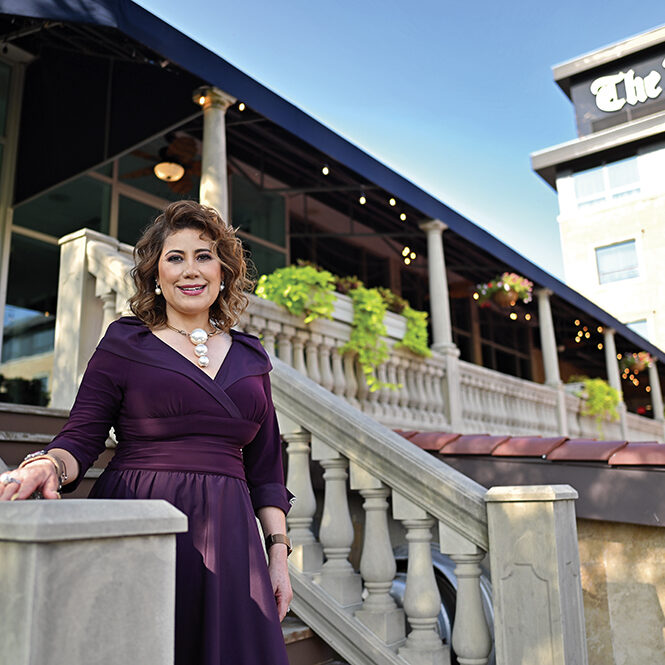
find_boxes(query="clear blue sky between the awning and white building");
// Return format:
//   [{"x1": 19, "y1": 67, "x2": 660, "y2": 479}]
[{"x1": 139, "y1": 0, "x2": 665, "y2": 278}]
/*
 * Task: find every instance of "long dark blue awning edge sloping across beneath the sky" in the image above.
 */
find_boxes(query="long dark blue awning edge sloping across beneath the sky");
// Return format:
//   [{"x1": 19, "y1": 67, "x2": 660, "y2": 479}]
[{"x1": 0, "y1": 0, "x2": 665, "y2": 363}]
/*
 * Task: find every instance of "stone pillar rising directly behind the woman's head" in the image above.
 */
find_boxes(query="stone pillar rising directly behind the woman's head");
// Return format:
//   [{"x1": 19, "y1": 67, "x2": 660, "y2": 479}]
[{"x1": 194, "y1": 87, "x2": 236, "y2": 224}]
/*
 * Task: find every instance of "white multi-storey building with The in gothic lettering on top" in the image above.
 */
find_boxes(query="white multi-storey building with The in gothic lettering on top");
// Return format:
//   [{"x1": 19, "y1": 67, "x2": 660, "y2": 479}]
[{"x1": 532, "y1": 27, "x2": 665, "y2": 348}]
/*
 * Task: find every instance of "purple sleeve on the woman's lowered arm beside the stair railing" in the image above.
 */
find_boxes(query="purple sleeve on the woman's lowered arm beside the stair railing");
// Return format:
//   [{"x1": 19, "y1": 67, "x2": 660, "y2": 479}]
[{"x1": 243, "y1": 374, "x2": 294, "y2": 513}]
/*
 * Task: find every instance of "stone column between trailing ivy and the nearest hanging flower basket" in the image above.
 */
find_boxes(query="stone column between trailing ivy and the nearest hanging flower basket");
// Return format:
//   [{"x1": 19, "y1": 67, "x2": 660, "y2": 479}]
[{"x1": 420, "y1": 219, "x2": 463, "y2": 432}]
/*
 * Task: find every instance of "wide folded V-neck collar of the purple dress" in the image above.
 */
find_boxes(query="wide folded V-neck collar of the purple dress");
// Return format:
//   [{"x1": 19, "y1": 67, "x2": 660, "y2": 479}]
[{"x1": 98, "y1": 316, "x2": 272, "y2": 419}]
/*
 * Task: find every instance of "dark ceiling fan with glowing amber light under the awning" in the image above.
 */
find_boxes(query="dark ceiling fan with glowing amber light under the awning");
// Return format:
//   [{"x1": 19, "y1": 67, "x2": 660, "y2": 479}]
[{"x1": 120, "y1": 133, "x2": 201, "y2": 194}]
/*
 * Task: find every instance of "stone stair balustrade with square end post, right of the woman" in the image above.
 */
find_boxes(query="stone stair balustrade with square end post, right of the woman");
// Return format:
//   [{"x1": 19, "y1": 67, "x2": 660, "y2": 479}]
[{"x1": 272, "y1": 358, "x2": 586, "y2": 665}]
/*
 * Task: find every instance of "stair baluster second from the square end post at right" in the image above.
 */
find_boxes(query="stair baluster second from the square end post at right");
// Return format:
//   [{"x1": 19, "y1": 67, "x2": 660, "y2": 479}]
[{"x1": 393, "y1": 492, "x2": 450, "y2": 665}]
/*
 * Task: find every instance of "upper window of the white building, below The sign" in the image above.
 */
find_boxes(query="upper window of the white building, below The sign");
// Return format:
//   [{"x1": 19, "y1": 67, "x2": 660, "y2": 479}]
[{"x1": 573, "y1": 157, "x2": 640, "y2": 208}]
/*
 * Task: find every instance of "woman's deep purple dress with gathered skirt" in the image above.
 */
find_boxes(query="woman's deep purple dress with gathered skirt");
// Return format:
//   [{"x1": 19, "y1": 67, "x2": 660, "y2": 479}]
[{"x1": 48, "y1": 317, "x2": 291, "y2": 665}]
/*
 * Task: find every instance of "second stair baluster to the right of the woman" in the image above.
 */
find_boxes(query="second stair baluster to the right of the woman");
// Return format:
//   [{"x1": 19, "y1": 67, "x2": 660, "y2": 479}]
[{"x1": 312, "y1": 438, "x2": 362, "y2": 608}]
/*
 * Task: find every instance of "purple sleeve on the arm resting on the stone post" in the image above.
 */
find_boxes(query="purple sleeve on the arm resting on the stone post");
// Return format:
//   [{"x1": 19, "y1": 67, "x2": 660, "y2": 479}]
[{"x1": 46, "y1": 349, "x2": 124, "y2": 492}]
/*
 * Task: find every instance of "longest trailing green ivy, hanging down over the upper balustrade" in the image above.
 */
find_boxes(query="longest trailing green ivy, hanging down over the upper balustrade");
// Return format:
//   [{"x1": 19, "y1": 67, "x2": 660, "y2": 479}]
[{"x1": 340, "y1": 286, "x2": 396, "y2": 392}]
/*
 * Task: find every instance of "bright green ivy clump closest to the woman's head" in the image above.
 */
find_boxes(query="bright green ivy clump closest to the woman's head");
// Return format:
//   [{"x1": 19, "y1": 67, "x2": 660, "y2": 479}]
[{"x1": 255, "y1": 265, "x2": 335, "y2": 323}]
